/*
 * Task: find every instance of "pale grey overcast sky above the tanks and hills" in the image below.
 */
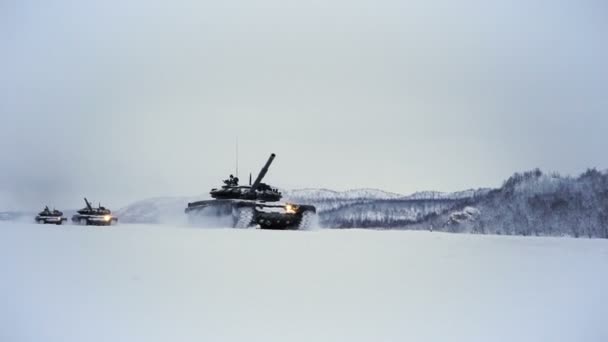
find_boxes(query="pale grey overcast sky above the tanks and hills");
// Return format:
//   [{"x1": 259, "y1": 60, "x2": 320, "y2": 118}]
[{"x1": 0, "y1": 0, "x2": 608, "y2": 211}]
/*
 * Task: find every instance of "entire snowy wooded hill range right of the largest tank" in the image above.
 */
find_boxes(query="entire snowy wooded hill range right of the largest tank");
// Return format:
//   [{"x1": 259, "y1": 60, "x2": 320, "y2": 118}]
[{"x1": 294, "y1": 169, "x2": 608, "y2": 238}]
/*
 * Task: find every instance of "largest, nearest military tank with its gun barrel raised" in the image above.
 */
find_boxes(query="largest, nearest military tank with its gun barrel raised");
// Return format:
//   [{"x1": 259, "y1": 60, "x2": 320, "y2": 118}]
[{"x1": 185, "y1": 153, "x2": 317, "y2": 229}]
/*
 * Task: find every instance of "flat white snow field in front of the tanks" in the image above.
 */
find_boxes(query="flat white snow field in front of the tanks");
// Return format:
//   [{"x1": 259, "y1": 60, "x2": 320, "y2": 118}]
[{"x1": 0, "y1": 222, "x2": 608, "y2": 342}]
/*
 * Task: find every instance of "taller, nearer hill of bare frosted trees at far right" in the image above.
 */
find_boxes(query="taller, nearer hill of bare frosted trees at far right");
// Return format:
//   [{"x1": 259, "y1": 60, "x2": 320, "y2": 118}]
[{"x1": 428, "y1": 169, "x2": 608, "y2": 238}]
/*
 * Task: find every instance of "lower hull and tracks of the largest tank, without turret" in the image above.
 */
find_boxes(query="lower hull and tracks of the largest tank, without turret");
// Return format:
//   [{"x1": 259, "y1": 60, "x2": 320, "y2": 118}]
[{"x1": 185, "y1": 199, "x2": 316, "y2": 230}]
